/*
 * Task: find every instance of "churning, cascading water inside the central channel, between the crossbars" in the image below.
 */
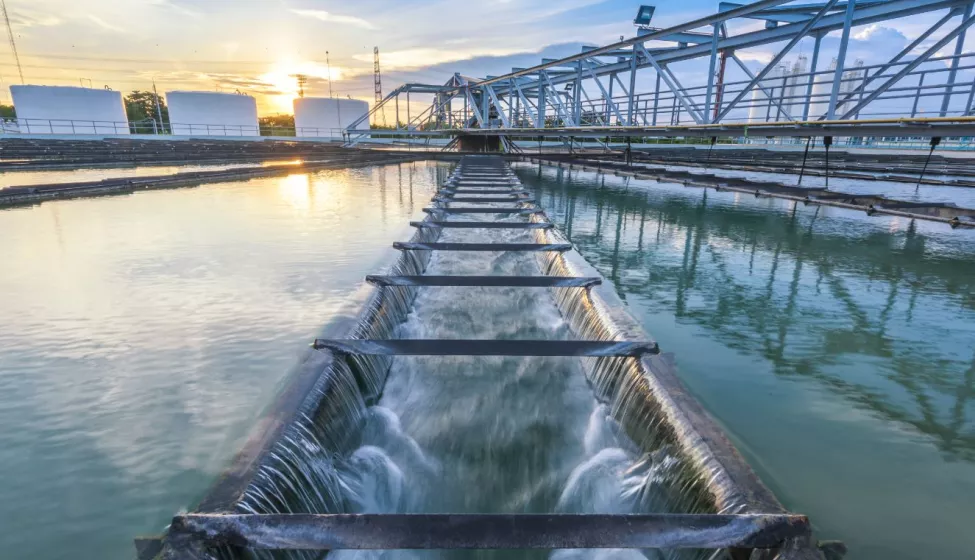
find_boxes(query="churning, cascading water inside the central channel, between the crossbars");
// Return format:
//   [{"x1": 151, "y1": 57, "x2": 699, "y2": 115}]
[{"x1": 215, "y1": 160, "x2": 740, "y2": 559}]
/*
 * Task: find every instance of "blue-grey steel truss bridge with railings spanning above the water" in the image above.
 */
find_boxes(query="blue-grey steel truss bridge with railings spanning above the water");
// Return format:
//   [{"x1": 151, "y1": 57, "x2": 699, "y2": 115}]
[{"x1": 347, "y1": 0, "x2": 975, "y2": 148}]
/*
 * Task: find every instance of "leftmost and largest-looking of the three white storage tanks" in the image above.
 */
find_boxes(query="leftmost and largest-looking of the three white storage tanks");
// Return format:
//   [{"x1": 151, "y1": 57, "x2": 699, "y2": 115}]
[{"x1": 10, "y1": 86, "x2": 129, "y2": 134}]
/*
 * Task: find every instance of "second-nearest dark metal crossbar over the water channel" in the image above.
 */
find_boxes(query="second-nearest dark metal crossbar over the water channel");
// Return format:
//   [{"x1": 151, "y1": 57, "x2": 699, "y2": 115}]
[{"x1": 312, "y1": 338, "x2": 660, "y2": 358}]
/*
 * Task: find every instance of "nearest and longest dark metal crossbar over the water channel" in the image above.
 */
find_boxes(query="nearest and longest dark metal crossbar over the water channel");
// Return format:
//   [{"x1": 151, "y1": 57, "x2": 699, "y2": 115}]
[{"x1": 169, "y1": 513, "x2": 811, "y2": 550}]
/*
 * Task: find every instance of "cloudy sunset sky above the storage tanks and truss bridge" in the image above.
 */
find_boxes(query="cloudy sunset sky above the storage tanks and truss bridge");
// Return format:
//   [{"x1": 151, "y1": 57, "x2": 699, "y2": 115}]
[{"x1": 0, "y1": 0, "x2": 975, "y2": 115}]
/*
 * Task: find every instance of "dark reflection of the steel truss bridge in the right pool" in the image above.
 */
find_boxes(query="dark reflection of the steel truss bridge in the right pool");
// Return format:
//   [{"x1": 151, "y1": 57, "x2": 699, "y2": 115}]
[{"x1": 520, "y1": 162, "x2": 975, "y2": 461}]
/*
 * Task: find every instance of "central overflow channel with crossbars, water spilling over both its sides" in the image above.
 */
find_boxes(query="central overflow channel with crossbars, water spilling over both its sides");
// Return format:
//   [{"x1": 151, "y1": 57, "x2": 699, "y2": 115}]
[{"x1": 145, "y1": 156, "x2": 843, "y2": 560}]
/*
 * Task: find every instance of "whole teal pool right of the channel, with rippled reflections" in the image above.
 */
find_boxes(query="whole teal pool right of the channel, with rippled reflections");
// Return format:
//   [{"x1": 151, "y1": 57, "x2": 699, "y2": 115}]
[{"x1": 519, "y1": 165, "x2": 975, "y2": 560}]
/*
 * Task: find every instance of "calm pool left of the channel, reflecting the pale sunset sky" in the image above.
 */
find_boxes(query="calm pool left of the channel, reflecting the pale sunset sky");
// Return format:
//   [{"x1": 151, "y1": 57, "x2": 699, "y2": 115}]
[{"x1": 0, "y1": 160, "x2": 446, "y2": 558}]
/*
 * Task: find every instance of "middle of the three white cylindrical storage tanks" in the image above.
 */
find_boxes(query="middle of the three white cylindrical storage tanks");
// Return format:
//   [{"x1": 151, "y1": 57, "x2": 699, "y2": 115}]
[{"x1": 166, "y1": 91, "x2": 260, "y2": 136}]
